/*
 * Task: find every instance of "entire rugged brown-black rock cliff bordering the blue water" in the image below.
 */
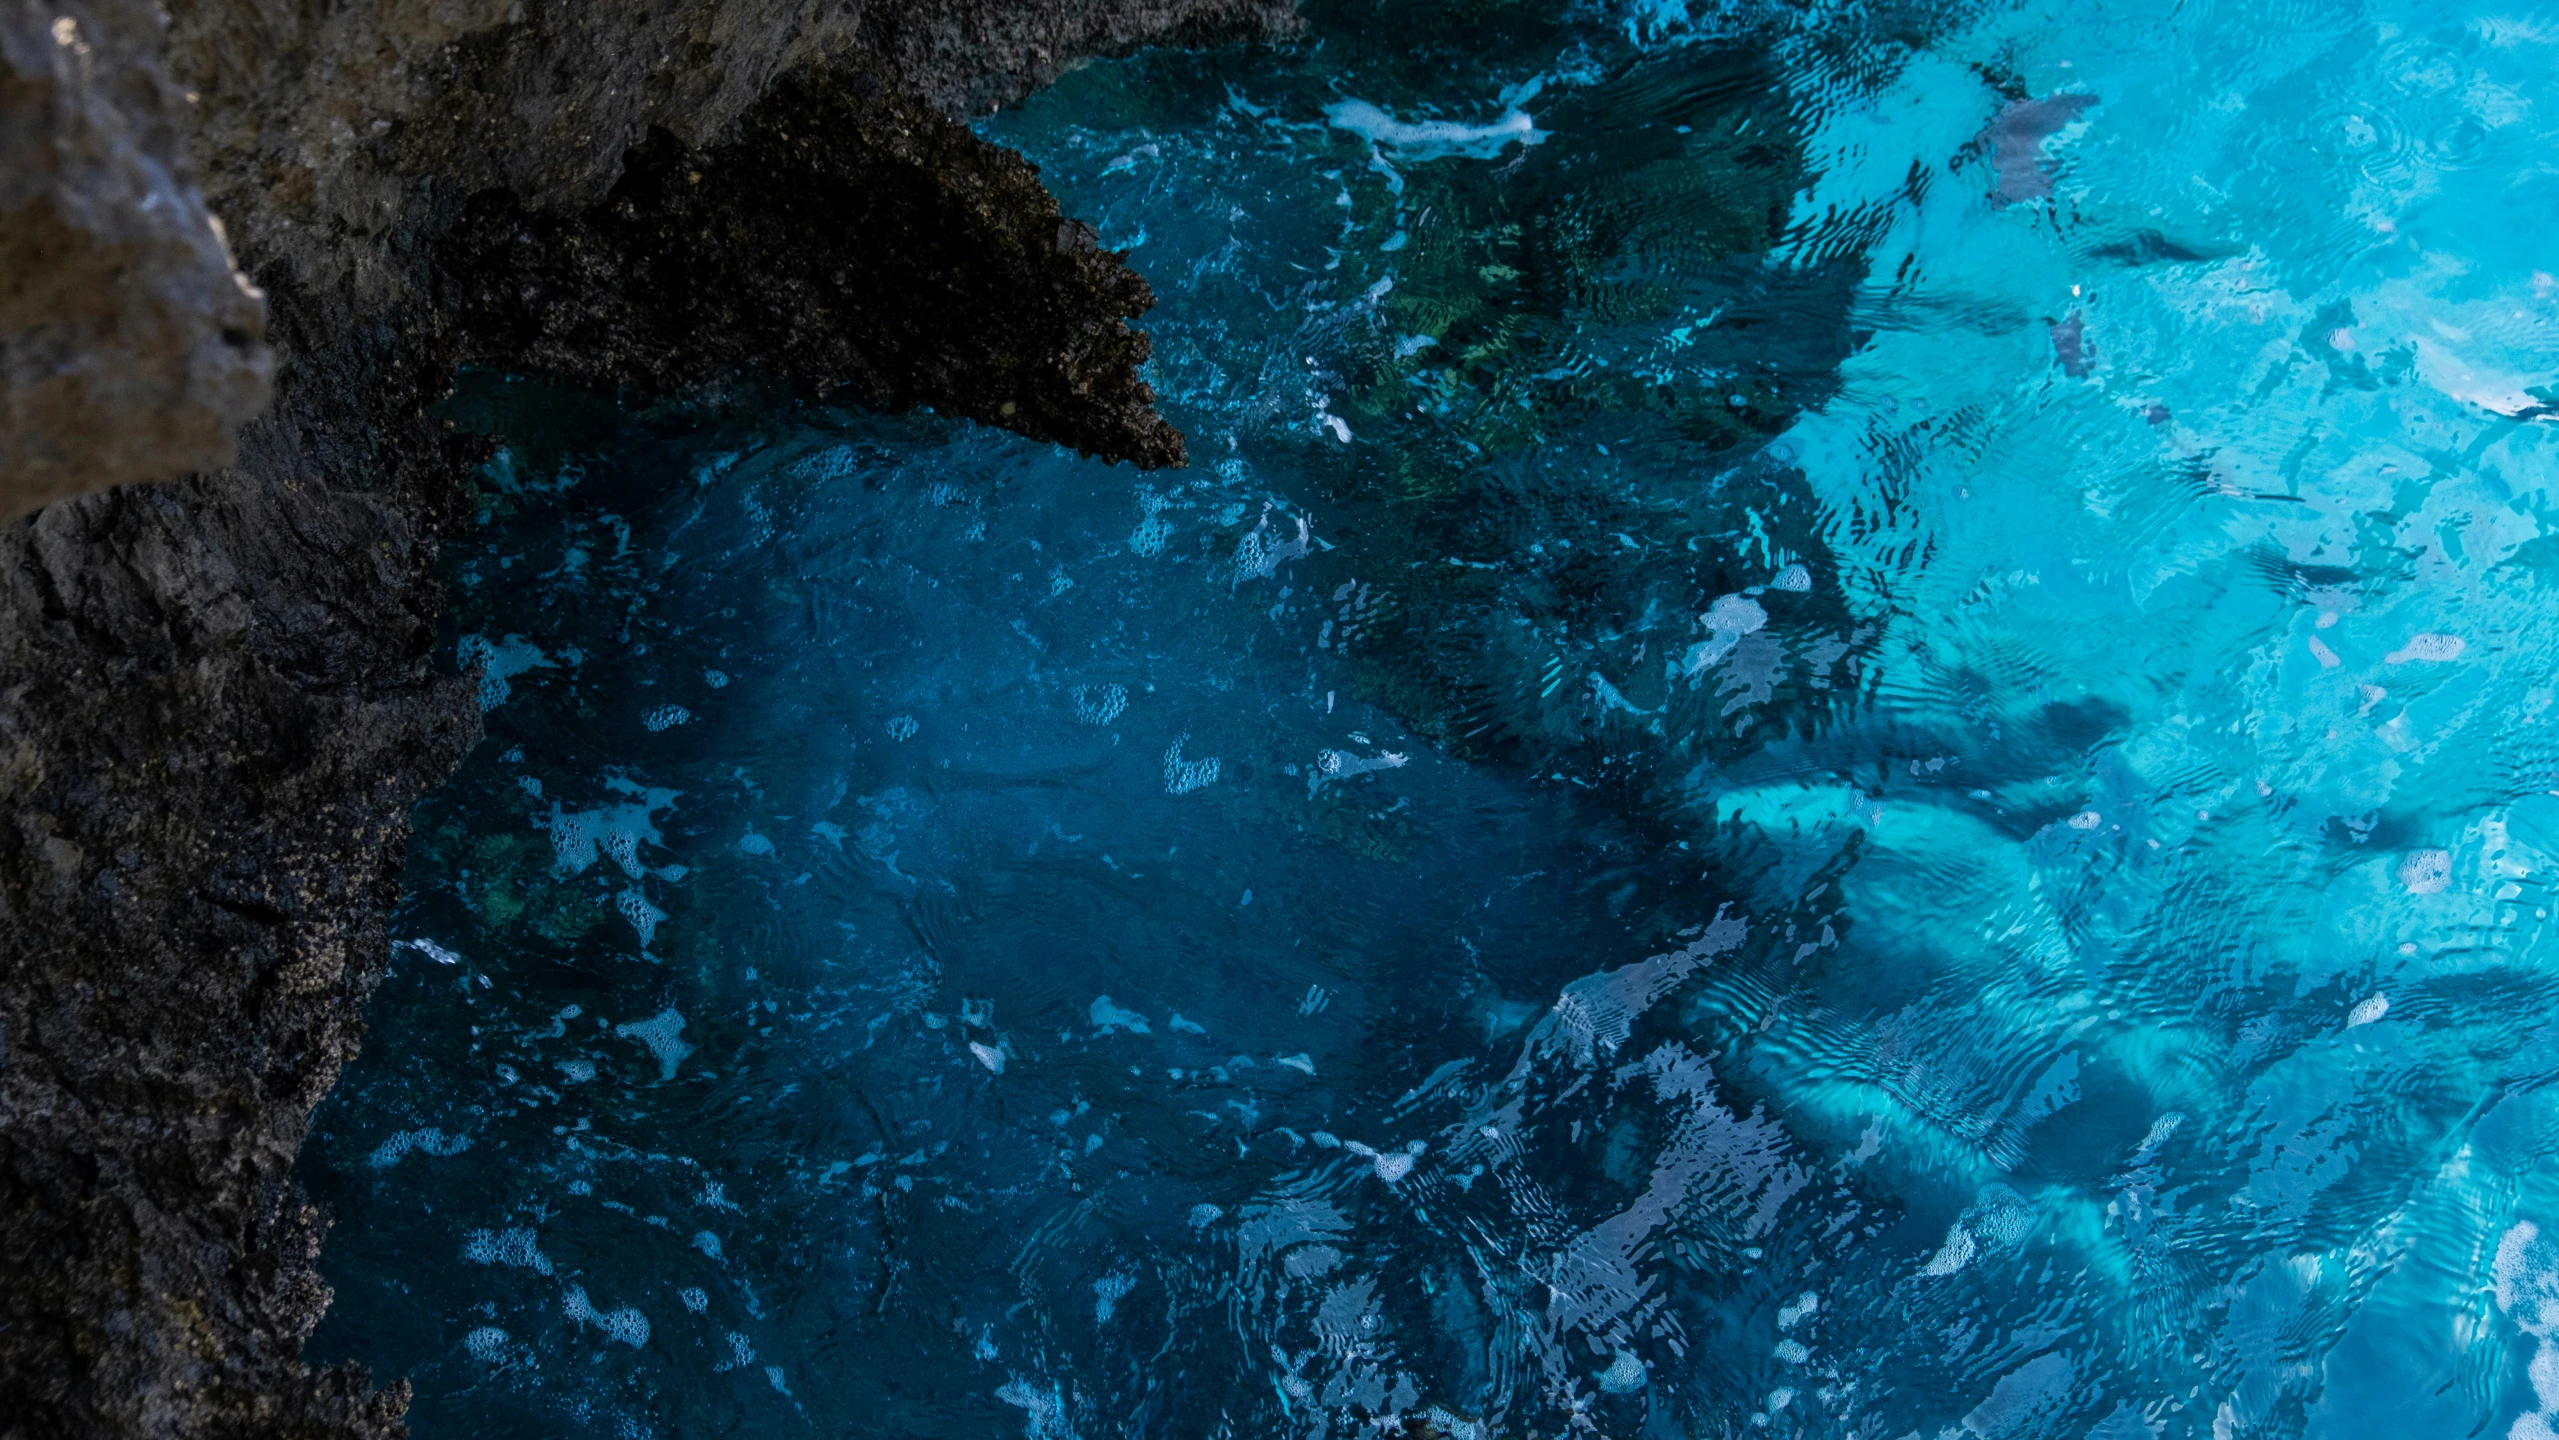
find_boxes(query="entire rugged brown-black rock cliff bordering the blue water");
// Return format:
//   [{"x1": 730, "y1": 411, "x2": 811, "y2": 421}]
[{"x1": 0, "y1": 0, "x2": 1290, "y2": 1440}]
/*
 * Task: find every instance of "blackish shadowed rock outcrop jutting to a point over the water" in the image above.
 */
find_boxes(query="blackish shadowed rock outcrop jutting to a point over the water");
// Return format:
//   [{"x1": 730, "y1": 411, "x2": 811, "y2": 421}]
[{"x1": 438, "y1": 72, "x2": 1182, "y2": 466}]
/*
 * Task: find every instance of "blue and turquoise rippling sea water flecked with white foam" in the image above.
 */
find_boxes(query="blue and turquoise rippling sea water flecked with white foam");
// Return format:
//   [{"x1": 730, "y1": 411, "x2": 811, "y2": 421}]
[{"x1": 302, "y1": 0, "x2": 2559, "y2": 1440}]
